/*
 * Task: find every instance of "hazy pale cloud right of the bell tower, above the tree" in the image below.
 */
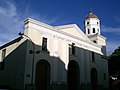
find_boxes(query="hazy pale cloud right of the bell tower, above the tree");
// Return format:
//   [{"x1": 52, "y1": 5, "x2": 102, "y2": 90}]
[{"x1": 101, "y1": 26, "x2": 120, "y2": 55}]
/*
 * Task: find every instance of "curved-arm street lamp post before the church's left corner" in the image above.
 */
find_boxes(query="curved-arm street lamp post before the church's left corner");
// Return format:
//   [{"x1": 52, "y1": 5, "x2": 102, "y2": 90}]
[{"x1": 18, "y1": 32, "x2": 35, "y2": 90}]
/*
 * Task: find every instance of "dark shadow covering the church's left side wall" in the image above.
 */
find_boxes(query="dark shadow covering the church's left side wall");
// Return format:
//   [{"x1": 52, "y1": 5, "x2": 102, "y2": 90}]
[{"x1": 0, "y1": 41, "x2": 27, "y2": 88}]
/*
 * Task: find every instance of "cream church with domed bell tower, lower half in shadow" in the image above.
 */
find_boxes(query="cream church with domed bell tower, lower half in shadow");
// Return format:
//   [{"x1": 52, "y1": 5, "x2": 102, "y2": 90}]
[{"x1": 0, "y1": 12, "x2": 109, "y2": 90}]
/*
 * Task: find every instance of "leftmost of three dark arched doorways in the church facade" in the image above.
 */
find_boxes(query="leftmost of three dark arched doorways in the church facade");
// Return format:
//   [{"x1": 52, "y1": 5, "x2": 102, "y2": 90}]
[{"x1": 36, "y1": 60, "x2": 50, "y2": 90}]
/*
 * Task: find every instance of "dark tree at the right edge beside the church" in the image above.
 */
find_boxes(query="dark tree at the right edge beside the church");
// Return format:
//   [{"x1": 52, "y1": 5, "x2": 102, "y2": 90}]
[{"x1": 108, "y1": 46, "x2": 120, "y2": 90}]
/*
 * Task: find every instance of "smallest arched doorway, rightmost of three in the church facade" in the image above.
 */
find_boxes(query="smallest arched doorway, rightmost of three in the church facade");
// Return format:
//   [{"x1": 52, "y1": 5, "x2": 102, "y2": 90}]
[{"x1": 91, "y1": 68, "x2": 98, "y2": 90}]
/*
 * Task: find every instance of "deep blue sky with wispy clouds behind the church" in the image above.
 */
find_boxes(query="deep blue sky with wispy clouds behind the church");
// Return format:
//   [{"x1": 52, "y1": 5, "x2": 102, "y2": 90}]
[{"x1": 0, "y1": 0, "x2": 120, "y2": 55}]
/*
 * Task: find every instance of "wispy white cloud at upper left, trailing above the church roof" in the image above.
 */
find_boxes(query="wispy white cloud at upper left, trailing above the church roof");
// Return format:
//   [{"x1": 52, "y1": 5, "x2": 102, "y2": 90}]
[{"x1": 0, "y1": 0, "x2": 57, "y2": 45}]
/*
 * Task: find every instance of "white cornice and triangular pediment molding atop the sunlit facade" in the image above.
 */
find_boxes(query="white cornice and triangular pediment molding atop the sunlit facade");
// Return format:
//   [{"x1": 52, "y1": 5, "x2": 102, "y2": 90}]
[{"x1": 24, "y1": 18, "x2": 102, "y2": 54}]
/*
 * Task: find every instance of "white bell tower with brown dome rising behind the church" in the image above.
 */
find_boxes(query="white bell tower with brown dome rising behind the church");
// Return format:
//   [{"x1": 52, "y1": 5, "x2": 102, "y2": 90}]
[{"x1": 84, "y1": 10, "x2": 106, "y2": 55}]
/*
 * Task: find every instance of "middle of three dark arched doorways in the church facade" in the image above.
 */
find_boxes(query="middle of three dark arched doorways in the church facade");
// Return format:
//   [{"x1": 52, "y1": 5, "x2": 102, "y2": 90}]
[{"x1": 67, "y1": 60, "x2": 80, "y2": 90}]
